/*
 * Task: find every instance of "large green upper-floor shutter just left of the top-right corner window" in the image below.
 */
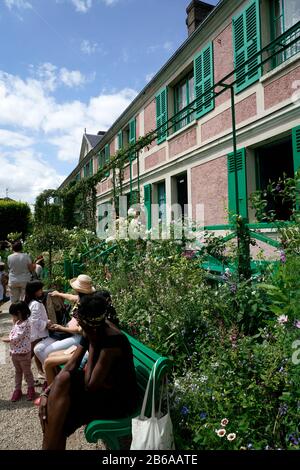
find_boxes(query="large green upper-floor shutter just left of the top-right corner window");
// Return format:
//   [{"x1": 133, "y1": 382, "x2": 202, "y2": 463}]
[{"x1": 232, "y1": 0, "x2": 261, "y2": 92}]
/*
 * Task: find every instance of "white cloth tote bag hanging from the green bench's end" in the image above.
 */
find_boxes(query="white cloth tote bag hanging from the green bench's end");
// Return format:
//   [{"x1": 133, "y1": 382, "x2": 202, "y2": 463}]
[{"x1": 130, "y1": 363, "x2": 175, "y2": 450}]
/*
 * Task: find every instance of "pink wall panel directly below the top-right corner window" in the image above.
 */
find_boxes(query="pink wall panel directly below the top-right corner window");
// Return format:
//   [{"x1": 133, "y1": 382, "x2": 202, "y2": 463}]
[{"x1": 264, "y1": 66, "x2": 300, "y2": 109}]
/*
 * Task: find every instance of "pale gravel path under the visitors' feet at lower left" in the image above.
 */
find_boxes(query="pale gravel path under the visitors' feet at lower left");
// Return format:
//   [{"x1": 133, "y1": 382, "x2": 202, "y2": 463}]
[{"x1": 0, "y1": 303, "x2": 104, "y2": 450}]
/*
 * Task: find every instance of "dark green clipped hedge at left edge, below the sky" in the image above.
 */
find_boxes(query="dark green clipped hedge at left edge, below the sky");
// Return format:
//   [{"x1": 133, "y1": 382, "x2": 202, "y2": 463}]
[{"x1": 0, "y1": 200, "x2": 31, "y2": 240}]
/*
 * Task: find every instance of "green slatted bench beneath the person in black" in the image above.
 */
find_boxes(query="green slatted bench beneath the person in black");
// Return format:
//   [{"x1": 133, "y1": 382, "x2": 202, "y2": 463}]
[{"x1": 85, "y1": 332, "x2": 170, "y2": 450}]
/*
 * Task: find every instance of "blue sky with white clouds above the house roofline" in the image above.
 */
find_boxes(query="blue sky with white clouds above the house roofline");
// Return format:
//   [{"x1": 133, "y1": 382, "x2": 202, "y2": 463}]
[{"x1": 0, "y1": 0, "x2": 217, "y2": 203}]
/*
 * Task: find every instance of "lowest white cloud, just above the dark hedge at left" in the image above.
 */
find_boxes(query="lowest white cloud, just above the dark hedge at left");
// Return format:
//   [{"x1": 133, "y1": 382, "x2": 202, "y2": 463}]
[{"x1": 0, "y1": 149, "x2": 64, "y2": 203}]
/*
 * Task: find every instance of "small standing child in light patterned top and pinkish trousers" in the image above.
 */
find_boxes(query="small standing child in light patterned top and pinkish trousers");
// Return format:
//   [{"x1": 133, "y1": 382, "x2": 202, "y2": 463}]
[{"x1": 4, "y1": 301, "x2": 35, "y2": 401}]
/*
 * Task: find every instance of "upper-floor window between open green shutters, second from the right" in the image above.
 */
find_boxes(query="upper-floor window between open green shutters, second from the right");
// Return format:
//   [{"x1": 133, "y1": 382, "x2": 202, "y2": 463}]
[{"x1": 174, "y1": 72, "x2": 195, "y2": 132}]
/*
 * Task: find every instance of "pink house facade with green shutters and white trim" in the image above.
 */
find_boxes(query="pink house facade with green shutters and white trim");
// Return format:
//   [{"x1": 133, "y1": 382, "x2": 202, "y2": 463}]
[{"x1": 62, "y1": 0, "x2": 300, "y2": 241}]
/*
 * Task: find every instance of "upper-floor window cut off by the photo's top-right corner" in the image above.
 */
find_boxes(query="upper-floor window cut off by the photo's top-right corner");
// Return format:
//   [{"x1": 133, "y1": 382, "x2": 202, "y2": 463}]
[{"x1": 270, "y1": 0, "x2": 300, "y2": 67}]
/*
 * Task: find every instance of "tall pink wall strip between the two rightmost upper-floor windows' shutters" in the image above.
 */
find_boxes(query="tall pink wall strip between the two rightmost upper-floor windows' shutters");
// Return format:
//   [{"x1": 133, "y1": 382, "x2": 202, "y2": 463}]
[{"x1": 214, "y1": 23, "x2": 234, "y2": 107}]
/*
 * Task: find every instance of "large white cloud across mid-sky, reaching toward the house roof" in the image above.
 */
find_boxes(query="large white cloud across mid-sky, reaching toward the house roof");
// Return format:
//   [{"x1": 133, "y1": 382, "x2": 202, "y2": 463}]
[{"x1": 0, "y1": 66, "x2": 137, "y2": 166}]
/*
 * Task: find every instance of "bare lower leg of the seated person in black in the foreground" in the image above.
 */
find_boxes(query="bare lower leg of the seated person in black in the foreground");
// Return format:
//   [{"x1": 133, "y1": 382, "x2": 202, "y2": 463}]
[{"x1": 43, "y1": 371, "x2": 70, "y2": 450}]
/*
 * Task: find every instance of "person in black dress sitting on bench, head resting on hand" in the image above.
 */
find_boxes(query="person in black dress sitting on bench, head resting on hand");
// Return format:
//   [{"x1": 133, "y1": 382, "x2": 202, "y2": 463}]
[{"x1": 39, "y1": 293, "x2": 137, "y2": 450}]
